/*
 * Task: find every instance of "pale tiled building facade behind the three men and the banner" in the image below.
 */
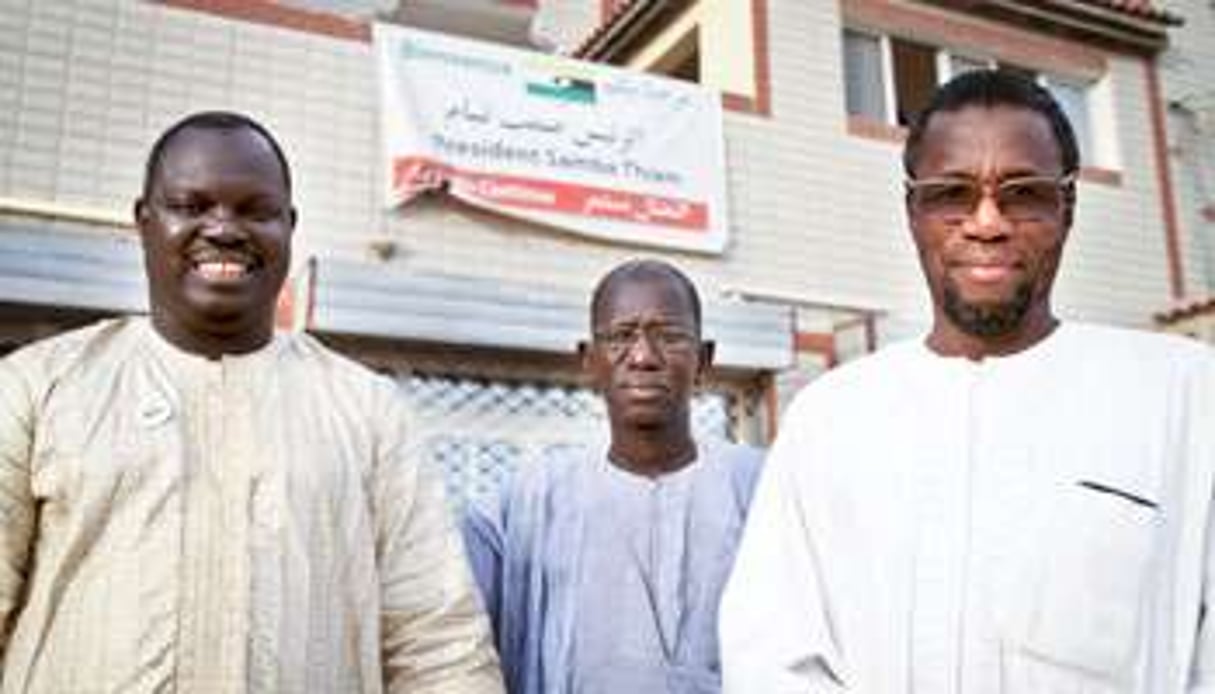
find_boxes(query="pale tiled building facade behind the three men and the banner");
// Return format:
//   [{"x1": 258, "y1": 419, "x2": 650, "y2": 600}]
[{"x1": 0, "y1": 0, "x2": 1215, "y2": 486}]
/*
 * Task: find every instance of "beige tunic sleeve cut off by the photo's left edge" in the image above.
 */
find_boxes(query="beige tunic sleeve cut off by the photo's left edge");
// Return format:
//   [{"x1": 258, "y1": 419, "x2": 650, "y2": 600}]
[{"x1": 0, "y1": 357, "x2": 35, "y2": 672}]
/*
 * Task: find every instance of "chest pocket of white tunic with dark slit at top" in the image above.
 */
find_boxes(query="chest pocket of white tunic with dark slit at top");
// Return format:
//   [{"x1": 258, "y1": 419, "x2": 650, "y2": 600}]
[{"x1": 1011, "y1": 480, "x2": 1160, "y2": 693}]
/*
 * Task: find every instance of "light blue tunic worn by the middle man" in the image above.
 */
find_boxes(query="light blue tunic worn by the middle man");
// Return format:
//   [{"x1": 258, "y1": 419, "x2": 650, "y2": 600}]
[{"x1": 464, "y1": 445, "x2": 762, "y2": 694}]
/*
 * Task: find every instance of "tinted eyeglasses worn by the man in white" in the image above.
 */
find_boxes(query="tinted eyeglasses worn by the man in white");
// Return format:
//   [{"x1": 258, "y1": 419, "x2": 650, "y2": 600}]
[{"x1": 904, "y1": 174, "x2": 1075, "y2": 224}]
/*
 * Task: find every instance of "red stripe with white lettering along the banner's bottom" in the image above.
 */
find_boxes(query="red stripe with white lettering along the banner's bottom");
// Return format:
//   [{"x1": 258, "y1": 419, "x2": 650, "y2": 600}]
[{"x1": 392, "y1": 157, "x2": 708, "y2": 232}]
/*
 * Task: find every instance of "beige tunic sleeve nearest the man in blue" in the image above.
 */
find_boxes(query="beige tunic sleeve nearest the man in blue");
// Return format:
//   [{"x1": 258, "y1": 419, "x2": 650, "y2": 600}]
[{"x1": 375, "y1": 393, "x2": 503, "y2": 694}]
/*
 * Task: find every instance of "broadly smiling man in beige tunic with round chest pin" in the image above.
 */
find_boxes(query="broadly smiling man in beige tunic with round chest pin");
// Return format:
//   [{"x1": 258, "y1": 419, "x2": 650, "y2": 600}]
[{"x1": 0, "y1": 113, "x2": 502, "y2": 694}]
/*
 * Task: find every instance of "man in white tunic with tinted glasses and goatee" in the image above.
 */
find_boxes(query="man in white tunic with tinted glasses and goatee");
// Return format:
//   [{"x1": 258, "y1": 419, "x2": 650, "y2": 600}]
[{"x1": 722, "y1": 72, "x2": 1215, "y2": 694}]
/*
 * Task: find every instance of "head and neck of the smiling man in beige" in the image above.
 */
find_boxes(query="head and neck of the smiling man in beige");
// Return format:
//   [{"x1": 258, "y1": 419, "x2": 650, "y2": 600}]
[{"x1": 135, "y1": 115, "x2": 295, "y2": 359}]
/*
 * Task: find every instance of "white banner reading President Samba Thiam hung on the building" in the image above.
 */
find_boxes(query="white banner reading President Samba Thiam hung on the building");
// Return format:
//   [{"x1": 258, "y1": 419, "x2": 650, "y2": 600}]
[{"x1": 374, "y1": 24, "x2": 728, "y2": 253}]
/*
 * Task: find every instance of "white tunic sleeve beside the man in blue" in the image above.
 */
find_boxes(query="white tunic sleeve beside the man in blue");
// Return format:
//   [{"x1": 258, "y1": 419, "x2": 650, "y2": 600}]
[{"x1": 719, "y1": 396, "x2": 847, "y2": 694}]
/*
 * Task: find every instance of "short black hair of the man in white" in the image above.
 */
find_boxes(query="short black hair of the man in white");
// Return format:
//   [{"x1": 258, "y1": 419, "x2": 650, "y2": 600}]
[{"x1": 903, "y1": 69, "x2": 1080, "y2": 179}]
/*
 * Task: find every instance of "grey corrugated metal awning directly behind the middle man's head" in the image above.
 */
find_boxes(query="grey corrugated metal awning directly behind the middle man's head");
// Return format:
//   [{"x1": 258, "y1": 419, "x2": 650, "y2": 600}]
[{"x1": 305, "y1": 259, "x2": 793, "y2": 371}]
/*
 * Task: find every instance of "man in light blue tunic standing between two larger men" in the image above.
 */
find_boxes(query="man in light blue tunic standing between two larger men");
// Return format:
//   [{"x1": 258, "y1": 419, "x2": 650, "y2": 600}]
[{"x1": 465, "y1": 260, "x2": 759, "y2": 694}]
